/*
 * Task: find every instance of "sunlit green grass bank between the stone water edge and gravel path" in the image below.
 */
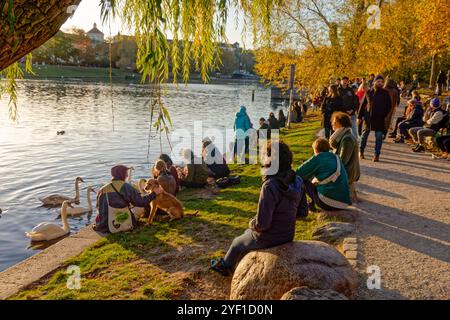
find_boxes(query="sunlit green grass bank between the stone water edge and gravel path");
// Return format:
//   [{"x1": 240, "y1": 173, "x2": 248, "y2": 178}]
[{"x1": 13, "y1": 116, "x2": 326, "y2": 299}]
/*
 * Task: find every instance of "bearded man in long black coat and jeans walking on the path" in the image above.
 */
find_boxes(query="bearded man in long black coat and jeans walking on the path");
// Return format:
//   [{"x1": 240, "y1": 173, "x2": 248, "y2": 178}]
[{"x1": 358, "y1": 75, "x2": 392, "y2": 162}]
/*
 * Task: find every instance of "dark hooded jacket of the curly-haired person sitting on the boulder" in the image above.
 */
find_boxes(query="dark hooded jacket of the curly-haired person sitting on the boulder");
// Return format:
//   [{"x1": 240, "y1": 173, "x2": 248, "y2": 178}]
[{"x1": 250, "y1": 170, "x2": 308, "y2": 245}]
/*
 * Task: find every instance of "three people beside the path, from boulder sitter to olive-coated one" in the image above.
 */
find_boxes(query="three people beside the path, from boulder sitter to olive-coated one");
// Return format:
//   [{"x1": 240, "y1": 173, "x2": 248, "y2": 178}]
[{"x1": 211, "y1": 112, "x2": 360, "y2": 276}]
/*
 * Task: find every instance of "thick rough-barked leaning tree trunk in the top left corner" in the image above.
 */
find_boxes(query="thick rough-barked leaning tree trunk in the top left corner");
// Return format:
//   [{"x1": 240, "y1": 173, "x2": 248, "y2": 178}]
[{"x1": 0, "y1": 0, "x2": 81, "y2": 71}]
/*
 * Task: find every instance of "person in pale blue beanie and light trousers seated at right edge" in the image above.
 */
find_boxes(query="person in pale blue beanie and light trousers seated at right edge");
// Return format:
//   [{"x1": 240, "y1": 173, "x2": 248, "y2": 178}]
[{"x1": 409, "y1": 98, "x2": 448, "y2": 152}]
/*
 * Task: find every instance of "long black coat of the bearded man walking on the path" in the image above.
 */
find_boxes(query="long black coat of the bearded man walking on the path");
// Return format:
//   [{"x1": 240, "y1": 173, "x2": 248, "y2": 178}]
[{"x1": 358, "y1": 89, "x2": 392, "y2": 132}]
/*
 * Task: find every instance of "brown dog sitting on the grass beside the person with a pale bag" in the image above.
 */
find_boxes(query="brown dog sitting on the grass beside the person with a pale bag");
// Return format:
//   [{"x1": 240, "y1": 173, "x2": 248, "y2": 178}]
[{"x1": 145, "y1": 179, "x2": 184, "y2": 224}]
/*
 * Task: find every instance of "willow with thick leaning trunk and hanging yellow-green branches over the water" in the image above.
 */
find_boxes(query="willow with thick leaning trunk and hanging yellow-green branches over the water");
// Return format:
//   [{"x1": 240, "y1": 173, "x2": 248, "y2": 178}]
[{"x1": 0, "y1": 0, "x2": 283, "y2": 122}]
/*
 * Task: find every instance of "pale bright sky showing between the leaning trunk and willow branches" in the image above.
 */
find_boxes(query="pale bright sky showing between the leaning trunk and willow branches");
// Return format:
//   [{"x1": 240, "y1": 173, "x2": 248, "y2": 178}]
[{"x1": 61, "y1": 0, "x2": 251, "y2": 48}]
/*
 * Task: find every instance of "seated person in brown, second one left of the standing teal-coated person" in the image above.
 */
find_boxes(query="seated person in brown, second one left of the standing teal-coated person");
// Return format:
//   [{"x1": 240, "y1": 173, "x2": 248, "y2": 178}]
[{"x1": 178, "y1": 149, "x2": 213, "y2": 188}]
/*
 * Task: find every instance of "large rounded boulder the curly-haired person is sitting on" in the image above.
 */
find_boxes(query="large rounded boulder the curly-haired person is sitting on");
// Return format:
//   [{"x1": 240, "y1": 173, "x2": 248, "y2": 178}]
[{"x1": 230, "y1": 241, "x2": 358, "y2": 300}]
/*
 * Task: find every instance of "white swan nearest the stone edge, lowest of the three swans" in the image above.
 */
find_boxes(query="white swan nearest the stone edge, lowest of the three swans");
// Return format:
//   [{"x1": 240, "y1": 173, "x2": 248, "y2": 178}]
[{"x1": 25, "y1": 201, "x2": 72, "y2": 241}]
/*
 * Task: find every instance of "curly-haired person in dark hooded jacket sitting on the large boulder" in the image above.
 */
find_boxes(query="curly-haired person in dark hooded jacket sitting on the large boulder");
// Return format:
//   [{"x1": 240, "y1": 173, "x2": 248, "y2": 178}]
[{"x1": 211, "y1": 141, "x2": 308, "y2": 276}]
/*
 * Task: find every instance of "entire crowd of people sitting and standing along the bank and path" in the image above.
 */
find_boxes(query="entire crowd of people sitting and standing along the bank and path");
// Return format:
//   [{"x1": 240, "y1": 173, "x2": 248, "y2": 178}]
[{"x1": 89, "y1": 70, "x2": 450, "y2": 276}]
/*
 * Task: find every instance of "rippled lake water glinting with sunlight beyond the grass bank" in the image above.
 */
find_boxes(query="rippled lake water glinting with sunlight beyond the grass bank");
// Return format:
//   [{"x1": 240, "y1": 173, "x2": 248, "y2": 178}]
[{"x1": 0, "y1": 81, "x2": 284, "y2": 270}]
